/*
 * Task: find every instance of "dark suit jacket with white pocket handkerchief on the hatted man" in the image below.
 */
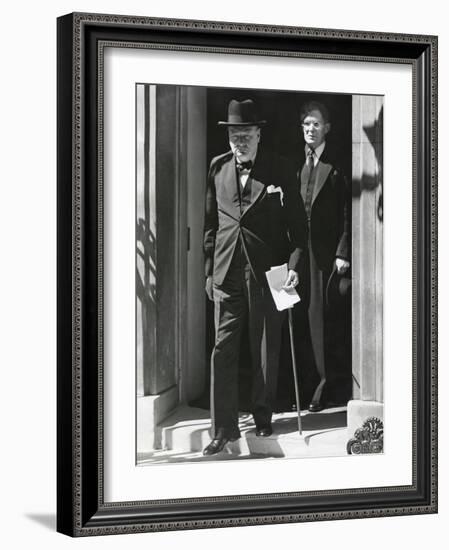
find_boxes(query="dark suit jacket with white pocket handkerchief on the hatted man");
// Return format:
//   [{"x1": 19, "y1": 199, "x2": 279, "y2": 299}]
[{"x1": 204, "y1": 148, "x2": 307, "y2": 286}]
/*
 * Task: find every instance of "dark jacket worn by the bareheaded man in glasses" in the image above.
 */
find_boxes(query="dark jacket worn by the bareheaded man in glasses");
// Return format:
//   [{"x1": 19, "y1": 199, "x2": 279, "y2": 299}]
[{"x1": 298, "y1": 145, "x2": 351, "y2": 275}]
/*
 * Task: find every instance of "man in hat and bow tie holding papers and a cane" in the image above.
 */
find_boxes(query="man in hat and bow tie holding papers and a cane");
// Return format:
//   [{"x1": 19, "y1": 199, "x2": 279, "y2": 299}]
[{"x1": 203, "y1": 100, "x2": 307, "y2": 455}]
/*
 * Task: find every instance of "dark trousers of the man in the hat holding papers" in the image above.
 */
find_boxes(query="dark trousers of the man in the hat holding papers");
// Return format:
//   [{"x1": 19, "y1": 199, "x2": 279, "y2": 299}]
[{"x1": 211, "y1": 252, "x2": 285, "y2": 437}]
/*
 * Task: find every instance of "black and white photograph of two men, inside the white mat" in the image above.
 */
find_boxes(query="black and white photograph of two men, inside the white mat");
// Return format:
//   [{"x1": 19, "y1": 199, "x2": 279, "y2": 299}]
[{"x1": 135, "y1": 83, "x2": 382, "y2": 466}]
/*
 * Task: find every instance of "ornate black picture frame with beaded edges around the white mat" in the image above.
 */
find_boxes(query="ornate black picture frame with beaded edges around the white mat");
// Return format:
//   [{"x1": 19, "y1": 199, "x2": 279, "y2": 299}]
[{"x1": 57, "y1": 13, "x2": 438, "y2": 536}]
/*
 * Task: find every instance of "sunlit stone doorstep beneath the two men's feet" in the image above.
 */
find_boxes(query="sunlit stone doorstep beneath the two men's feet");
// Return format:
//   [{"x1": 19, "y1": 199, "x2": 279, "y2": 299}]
[{"x1": 138, "y1": 406, "x2": 348, "y2": 464}]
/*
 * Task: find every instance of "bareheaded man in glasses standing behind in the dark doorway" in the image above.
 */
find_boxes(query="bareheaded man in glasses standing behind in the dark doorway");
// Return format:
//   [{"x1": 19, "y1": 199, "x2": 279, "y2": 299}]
[{"x1": 298, "y1": 101, "x2": 351, "y2": 412}]
